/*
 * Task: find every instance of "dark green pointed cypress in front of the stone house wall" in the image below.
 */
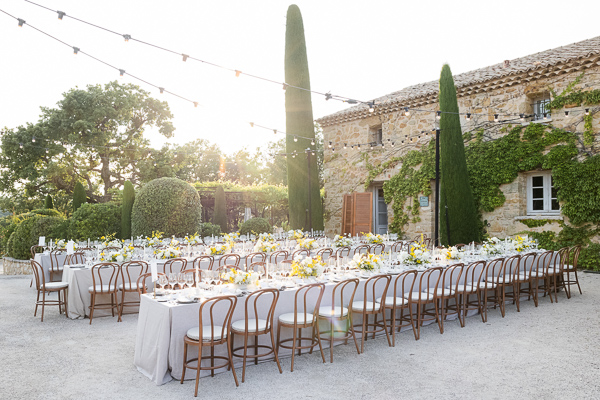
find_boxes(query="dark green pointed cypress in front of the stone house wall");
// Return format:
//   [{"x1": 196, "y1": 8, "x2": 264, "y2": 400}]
[{"x1": 439, "y1": 64, "x2": 480, "y2": 245}]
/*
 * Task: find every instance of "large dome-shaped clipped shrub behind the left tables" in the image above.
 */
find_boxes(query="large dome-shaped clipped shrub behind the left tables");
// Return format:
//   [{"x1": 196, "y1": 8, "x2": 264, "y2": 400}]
[{"x1": 131, "y1": 178, "x2": 202, "y2": 237}]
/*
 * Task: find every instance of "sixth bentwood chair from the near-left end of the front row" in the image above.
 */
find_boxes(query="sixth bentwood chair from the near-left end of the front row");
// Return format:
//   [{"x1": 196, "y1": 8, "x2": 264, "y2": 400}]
[{"x1": 375, "y1": 269, "x2": 419, "y2": 347}]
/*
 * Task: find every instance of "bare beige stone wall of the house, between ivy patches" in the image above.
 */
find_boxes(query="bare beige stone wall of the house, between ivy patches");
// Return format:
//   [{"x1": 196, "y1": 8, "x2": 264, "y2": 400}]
[{"x1": 322, "y1": 66, "x2": 600, "y2": 238}]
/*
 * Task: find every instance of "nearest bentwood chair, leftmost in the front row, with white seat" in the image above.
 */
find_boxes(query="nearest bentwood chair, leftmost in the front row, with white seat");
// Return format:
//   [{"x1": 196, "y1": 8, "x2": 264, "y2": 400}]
[{"x1": 179, "y1": 296, "x2": 243, "y2": 397}]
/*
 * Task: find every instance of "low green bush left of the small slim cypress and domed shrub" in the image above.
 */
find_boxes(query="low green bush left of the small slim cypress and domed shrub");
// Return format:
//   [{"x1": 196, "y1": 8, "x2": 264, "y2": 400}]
[{"x1": 69, "y1": 203, "x2": 121, "y2": 240}]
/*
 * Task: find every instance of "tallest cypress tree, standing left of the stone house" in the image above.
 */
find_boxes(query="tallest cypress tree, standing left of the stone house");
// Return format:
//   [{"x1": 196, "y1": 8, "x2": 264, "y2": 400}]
[{"x1": 285, "y1": 4, "x2": 323, "y2": 230}]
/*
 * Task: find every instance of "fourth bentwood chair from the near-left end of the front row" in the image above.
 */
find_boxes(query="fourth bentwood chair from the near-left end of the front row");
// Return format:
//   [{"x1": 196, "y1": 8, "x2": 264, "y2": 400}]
[{"x1": 317, "y1": 278, "x2": 360, "y2": 362}]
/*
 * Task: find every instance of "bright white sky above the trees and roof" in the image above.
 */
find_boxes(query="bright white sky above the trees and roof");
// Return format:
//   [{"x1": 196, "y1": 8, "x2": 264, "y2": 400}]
[{"x1": 0, "y1": 0, "x2": 600, "y2": 154}]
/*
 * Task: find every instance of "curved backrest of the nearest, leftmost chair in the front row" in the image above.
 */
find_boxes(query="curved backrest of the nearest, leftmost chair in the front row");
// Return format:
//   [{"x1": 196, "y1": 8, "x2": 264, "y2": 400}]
[{"x1": 198, "y1": 296, "x2": 237, "y2": 344}]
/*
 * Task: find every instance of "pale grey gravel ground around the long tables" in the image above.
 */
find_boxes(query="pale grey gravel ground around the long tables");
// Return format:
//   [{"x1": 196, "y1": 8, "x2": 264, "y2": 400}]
[{"x1": 0, "y1": 274, "x2": 600, "y2": 399}]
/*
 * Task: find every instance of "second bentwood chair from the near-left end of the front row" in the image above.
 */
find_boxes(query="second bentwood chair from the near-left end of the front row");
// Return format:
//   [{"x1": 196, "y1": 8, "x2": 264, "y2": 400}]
[{"x1": 230, "y1": 288, "x2": 282, "y2": 383}]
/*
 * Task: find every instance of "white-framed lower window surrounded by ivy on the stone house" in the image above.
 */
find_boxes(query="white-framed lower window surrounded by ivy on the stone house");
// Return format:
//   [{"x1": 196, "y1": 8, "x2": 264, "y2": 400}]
[{"x1": 527, "y1": 171, "x2": 560, "y2": 215}]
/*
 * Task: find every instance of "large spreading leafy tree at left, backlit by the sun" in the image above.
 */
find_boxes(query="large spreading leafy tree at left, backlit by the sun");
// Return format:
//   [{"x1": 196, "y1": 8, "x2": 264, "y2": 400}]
[{"x1": 0, "y1": 81, "x2": 174, "y2": 202}]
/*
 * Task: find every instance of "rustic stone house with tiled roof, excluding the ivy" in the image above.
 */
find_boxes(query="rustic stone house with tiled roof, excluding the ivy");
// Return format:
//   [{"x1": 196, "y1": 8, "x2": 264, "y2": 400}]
[{"x1": 317, "y1": 37, "x2": 600, "y2": 237}]
